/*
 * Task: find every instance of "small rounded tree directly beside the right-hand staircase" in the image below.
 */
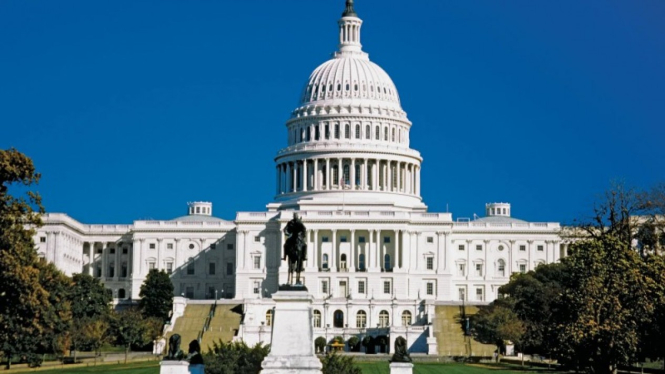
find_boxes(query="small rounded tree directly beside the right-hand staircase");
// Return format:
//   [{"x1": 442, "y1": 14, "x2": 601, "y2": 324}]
[{"x1": 471, "y1": 299, "x2": 525, "y2": 351}]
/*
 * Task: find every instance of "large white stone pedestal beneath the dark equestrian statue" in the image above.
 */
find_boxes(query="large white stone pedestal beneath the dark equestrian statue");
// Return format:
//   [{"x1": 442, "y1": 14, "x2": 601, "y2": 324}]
[{"x1": 261, "y1": 291, "x2": 322, "y2": 374}]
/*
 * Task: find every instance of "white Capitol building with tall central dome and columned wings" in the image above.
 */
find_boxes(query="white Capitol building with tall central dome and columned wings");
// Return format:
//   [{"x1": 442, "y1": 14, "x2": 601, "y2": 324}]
[{"x1": 35, "y1": 1, "x2": 567, "y2": 353}]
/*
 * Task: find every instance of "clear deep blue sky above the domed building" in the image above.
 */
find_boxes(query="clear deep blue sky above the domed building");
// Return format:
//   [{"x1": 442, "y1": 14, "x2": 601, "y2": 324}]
[{"x1": 0, "y1": 0, "x2": 665, "y2": 223}]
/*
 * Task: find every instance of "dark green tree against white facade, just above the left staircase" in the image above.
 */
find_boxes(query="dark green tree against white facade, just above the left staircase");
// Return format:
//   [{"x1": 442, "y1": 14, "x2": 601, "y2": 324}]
[{"x1": 139, "y1": 269, "x2": 173, "y2": 321}]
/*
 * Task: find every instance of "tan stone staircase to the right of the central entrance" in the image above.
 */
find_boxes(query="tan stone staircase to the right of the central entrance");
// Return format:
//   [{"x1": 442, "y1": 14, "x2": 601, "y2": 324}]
[{"x1": 433, "y1": 305, "x2": 496, "y2": 357}]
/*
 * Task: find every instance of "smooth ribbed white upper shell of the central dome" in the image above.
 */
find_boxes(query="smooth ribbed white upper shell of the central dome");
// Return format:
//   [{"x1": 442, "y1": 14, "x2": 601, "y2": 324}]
[{"x1": 301, "y1": 57, "x2": 399, "y2": 105}]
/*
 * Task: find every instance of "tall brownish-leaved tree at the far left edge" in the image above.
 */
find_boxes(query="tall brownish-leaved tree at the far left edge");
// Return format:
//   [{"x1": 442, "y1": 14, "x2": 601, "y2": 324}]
[{"x1": 0, "y1": 149, "x2": 49, "y2": 368}]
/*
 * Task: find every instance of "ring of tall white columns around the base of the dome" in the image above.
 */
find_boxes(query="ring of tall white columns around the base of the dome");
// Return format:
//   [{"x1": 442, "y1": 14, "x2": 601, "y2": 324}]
[{"x1": 276, "y1": 157, "x2": 420, "y2": 196}]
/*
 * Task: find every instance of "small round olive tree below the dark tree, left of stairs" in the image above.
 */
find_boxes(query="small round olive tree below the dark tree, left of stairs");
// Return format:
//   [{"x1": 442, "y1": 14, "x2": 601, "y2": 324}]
[{"x1": 111, "y1": 308, "x2": 151, "y2": 363}]
